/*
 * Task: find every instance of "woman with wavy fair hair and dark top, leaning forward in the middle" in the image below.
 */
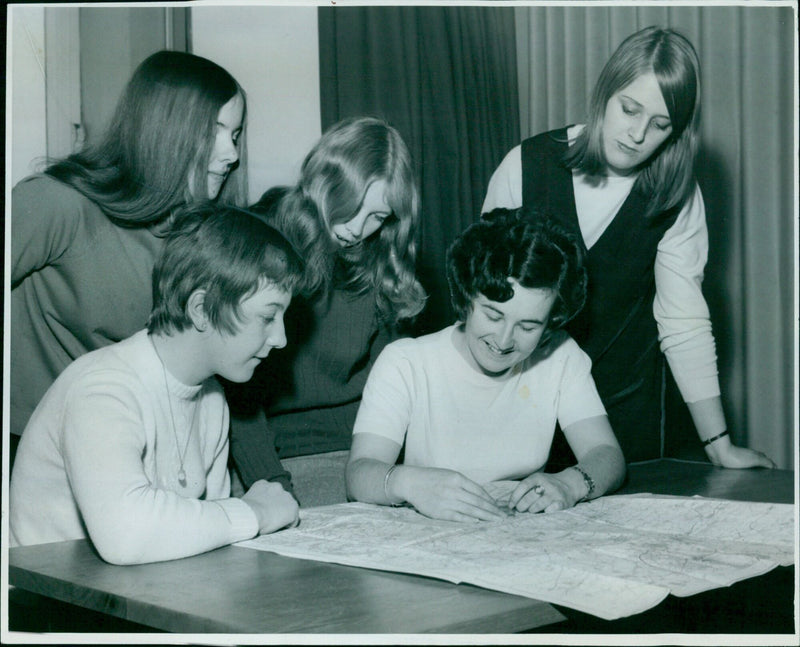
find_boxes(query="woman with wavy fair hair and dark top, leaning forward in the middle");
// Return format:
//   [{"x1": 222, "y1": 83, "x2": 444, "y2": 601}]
[{"x1": 228, "y1": 117, "x2": 425, "y2": 496}]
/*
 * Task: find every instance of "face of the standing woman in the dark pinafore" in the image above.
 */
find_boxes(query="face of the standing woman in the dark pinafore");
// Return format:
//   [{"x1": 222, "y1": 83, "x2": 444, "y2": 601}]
[{"x1": 603, "y1": 72, "x2": 672, "y2": 176}]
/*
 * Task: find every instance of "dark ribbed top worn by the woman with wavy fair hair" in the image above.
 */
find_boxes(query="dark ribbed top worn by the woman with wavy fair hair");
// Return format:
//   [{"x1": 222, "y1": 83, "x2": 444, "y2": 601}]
[{"x1": 226, "y1": 289, "x2": 397, "y2": 487}]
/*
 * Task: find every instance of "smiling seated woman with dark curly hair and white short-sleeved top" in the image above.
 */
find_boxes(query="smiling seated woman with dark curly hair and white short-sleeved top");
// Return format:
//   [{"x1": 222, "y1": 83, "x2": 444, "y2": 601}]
[{"x1": 346, "y1": 209, "x2": 625, "y2": 521}]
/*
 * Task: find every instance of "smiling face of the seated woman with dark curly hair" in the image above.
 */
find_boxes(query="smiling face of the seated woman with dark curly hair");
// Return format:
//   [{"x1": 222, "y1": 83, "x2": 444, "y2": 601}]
[{"x1": 456, "y1": 279, "x2": 556, "y2": 377}]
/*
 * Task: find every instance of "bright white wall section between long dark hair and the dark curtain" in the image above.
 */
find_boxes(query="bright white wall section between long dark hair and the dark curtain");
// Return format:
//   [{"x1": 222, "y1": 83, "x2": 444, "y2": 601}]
[{"x1": 191, "y1": 6, "x2": 321, "y2": 202}]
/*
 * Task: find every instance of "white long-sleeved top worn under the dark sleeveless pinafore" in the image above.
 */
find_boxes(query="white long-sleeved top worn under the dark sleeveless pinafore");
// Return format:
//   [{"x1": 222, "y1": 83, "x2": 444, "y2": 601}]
[{"x1": 483, "y1": 126, "x2": 720, "y2": 402}]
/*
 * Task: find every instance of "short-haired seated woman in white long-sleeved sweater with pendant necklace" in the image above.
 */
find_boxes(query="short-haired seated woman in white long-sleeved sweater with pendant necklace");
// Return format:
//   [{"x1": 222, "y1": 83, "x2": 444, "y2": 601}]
[{"x1": 10, "y1": 203, "x2": 303, "y2": 564}]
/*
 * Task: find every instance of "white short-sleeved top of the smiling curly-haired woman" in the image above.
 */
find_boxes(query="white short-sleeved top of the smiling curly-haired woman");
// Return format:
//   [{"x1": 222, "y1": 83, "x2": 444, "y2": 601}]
[{"x1": 353, "y1": 325, "x2": 605, "y2": 483}]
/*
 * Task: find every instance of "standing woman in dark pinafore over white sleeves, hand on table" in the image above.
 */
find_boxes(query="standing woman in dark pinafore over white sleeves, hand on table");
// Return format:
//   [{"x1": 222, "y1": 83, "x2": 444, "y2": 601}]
[{"x1": 483, "y1": 27, "x2": 773, "y2": 467}]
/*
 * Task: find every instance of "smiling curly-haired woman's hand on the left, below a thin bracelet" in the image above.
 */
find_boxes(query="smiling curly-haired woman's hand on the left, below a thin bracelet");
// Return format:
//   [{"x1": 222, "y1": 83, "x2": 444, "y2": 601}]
[{"x1": 404, "y1": 465, "x2": 508, "y2": 521}]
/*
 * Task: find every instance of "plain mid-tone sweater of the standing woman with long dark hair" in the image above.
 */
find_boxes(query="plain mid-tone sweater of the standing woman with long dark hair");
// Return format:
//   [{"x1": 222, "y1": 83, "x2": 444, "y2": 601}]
[{"x1": 9, "y1": 175, "x2": 163, "y2": 435}]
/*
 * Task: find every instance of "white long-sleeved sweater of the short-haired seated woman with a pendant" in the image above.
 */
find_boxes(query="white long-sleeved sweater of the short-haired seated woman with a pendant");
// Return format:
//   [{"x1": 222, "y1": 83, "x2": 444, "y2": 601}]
[{"x1": 10, "y1": 330, "x2": 258, "y2": 564}]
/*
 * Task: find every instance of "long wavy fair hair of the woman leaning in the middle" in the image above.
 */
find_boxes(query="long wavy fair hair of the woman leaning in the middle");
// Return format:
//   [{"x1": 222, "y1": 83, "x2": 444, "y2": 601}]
[{"x1": 298, "y1": 117, "x2": 426, "y2": 323}]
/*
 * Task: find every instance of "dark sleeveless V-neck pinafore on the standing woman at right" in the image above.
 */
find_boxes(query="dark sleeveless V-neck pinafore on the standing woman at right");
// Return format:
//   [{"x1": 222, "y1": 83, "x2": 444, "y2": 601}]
[{"x1": 522, "y1": 128, "x2": 679, "y2": 469}]
